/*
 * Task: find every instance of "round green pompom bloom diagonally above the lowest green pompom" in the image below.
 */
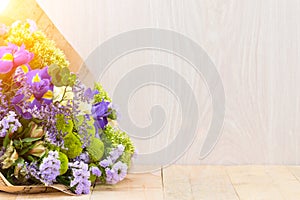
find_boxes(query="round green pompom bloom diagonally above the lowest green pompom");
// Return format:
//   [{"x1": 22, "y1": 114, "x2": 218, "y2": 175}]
[{"x1": 63, "y1": 133, "x2": 82, "y2": 159}]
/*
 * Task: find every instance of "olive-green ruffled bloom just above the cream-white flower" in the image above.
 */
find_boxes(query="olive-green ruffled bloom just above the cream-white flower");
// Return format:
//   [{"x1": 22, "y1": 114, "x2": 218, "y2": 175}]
[{"x1": 48, "y1": 64, "x2": 76, "y2": 87}]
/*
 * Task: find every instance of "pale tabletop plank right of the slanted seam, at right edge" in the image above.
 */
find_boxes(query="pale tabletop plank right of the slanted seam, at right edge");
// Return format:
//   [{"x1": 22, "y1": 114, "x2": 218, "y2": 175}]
[{"x1": 226, "y1": 166, "x2": 300, "y2": 199}]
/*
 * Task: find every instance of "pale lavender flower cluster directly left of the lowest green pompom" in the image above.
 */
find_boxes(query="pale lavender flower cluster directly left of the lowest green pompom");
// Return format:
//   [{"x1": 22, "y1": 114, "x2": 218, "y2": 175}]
[{"x1": 39, "y1": 151, "x2": 60, "y2": 185}]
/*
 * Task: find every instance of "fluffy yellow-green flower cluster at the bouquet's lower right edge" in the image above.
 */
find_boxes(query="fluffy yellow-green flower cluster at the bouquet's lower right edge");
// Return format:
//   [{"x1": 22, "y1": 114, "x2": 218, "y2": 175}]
[{"x1": 103, "y1": 125, "x2": 135, "y2": 155}]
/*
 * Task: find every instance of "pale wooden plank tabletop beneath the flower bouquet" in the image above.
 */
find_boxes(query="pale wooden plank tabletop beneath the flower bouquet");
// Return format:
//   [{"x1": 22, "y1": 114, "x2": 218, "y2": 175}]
[{"x1": 0, "y1": 166, "x2": 300, "y2": 200}]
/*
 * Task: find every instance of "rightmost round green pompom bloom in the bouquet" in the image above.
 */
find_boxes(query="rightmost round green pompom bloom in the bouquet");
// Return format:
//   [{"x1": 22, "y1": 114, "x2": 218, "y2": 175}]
[{"x1": 86, "y1": 137, "x2": 104, "y2": 162}]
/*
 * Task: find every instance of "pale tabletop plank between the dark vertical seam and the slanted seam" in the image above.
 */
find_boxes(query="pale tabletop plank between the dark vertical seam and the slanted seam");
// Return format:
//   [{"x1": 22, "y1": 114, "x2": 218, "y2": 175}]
[{"x1": 163, "y1": 166, "x2": 238, "y2": 200}]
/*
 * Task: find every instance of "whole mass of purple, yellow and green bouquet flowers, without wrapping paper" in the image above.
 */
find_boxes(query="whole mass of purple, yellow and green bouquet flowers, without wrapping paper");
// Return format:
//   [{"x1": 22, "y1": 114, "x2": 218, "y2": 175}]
[{"x1": 0, "y1": 20, "x2": 135, "y2": 194}]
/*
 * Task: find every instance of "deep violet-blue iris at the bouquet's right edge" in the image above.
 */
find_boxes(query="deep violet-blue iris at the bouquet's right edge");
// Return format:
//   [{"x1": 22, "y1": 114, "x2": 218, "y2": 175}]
[{"x1": 92, "y1": 100, "x2": 110, "y2": 129}]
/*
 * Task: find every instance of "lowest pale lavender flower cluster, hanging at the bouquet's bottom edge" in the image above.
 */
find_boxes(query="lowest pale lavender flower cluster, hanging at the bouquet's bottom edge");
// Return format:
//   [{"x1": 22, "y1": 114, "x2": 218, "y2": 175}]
[{"x1": 69, "y1": 161, "x2": 91, "y2": 194}]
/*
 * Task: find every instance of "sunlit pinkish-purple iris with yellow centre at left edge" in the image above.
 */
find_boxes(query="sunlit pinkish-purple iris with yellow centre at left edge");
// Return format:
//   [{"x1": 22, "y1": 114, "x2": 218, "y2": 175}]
[{"x1": 0, "y1": 44, "x2": 33, "y2": 74}]
